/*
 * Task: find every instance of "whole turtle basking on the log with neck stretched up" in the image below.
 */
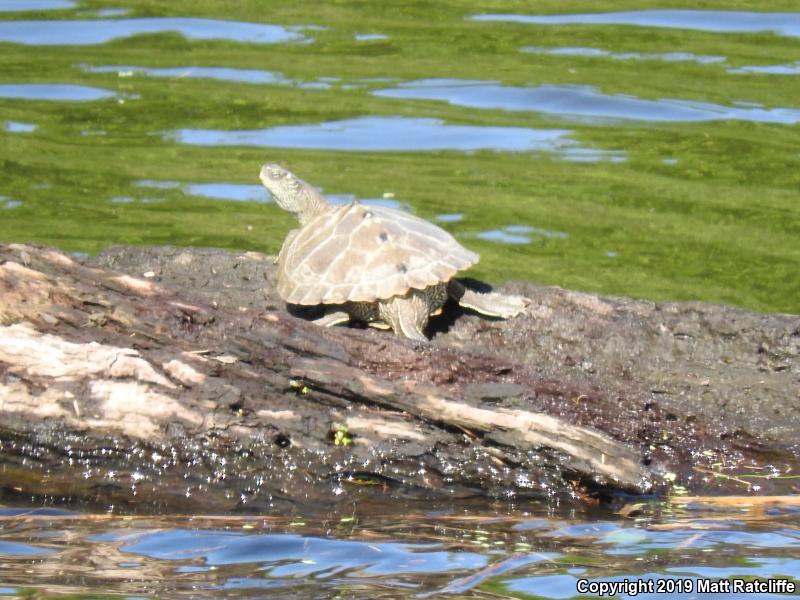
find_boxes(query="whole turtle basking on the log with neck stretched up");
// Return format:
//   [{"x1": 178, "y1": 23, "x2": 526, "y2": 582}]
[{"x1": 260, "y1": 163, "x2": 530, "y2": 341}]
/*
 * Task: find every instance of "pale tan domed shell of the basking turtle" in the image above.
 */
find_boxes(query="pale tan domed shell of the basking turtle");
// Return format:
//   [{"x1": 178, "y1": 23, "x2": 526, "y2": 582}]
[{"x1": 278, "y1": 202, "x2": 479, "y2": 304}]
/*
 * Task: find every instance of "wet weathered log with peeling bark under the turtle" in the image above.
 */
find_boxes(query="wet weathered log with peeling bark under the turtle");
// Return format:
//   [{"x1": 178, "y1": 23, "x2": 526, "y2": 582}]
[{"x1": 0, "y1": 245, "x2": 800, "y2": 511}]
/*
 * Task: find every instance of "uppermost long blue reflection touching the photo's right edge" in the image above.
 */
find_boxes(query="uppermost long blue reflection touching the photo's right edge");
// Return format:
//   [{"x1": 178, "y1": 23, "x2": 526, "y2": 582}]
[{"x1": 469, "y1": 10, "x2": 800, "y2": 36}]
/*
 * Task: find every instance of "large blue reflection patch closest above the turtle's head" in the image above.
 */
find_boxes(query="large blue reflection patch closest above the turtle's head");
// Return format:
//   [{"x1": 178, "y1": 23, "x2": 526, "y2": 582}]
[{"x1": 172, "y1": 117, "x2": 620, "y2": 160}]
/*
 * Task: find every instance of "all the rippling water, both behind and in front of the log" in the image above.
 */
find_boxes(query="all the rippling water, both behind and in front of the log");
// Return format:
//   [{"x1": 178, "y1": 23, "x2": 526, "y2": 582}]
[{"x1": 0, "y1": 0, "x2": 800, "y2": 598}]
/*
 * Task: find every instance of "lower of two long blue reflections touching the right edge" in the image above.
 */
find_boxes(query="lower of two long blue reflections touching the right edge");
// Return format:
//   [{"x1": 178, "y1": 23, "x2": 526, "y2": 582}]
[{"x1": 372, "y1": 79, "x2": 800, "y2": 124}]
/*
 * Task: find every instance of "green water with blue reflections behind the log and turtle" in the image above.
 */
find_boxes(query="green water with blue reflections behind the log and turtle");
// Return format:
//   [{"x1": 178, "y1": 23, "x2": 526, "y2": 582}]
[{"x1": 0, "y1": 0, "x2": 800, "y2": 312}]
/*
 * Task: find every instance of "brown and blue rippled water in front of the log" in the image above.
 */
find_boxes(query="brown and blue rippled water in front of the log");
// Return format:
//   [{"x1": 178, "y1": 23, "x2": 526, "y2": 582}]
[{"x1": 0, "y1": 503, "x2": 800, "y2": 599}]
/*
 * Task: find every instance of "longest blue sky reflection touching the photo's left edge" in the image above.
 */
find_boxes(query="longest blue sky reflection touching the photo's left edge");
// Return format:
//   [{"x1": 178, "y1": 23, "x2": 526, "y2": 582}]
[{"x1": 0, "y1": 17, "x2": 310, "y2": 46}]
